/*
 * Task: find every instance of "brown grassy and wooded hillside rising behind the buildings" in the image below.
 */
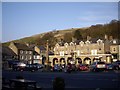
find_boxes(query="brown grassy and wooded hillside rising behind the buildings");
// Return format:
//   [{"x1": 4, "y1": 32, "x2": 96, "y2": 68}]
[{"x1": 3, "y1": 20, "x2": 120, "y2": 47}]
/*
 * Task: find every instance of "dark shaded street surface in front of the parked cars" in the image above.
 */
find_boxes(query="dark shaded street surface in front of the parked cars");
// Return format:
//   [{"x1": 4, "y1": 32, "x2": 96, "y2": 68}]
[{"x1": 2, "y1": 70, "x2": 120, "y2": 90}]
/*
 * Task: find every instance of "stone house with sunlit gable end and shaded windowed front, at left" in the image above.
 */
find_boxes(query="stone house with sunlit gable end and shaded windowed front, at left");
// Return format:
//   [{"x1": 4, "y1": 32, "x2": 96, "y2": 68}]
[{"x1": 9, "y1": 42, "x2": 33, "y2": 64}]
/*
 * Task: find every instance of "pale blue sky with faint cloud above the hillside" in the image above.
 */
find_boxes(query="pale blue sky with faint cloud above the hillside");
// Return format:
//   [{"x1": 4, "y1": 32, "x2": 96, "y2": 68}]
[{"x1": 2, "y1": 0, "x2": 118, "y2": 42}]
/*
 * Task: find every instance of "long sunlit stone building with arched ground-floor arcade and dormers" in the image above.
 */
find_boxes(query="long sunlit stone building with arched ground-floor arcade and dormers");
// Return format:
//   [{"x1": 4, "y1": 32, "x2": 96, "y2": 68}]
[{"x1": 49, "y1": 38, "x2": 112, "y2": 66}]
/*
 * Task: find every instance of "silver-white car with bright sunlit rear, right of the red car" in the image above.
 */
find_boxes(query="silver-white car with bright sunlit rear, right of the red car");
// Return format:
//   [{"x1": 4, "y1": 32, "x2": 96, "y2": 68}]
[{"x1": 89, "y1": 61, "x2": 106, "y2": 71}]
